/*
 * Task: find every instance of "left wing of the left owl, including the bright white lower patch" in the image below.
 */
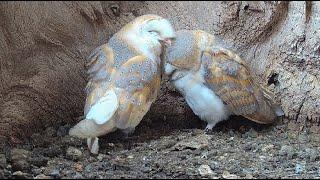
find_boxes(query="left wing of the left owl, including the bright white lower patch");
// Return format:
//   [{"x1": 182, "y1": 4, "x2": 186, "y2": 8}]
[{"x1": 84, "y1": 44, "x2": 119, "y2": 124}]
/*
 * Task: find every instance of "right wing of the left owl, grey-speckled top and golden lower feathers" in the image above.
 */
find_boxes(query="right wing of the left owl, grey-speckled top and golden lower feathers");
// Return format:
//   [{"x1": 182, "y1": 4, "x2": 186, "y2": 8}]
[{"x1": 114, "y1": 55, "x2": 161, "y2": 129}]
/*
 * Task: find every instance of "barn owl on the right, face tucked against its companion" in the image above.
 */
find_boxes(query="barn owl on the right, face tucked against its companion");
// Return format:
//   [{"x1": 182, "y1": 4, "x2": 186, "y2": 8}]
[{"x1": 164, "y1": 30, "x2": 283, "y2": 131}]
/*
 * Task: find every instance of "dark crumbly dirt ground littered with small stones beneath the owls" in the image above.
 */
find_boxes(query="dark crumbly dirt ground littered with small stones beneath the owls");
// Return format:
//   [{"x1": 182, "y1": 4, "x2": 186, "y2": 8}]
[{"x1": 0, "y1": 112, "x2": 320, "y2": 179}]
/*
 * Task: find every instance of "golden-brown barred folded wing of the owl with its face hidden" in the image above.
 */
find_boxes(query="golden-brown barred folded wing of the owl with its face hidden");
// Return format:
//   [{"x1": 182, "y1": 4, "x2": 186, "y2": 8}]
[{"x1": 204, "y1": 49, "x2": 276, "y2": 124}]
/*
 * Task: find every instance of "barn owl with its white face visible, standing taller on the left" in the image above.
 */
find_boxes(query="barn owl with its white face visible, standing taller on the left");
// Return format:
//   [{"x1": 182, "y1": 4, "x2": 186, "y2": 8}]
[{"x1": 69, "y1": 15, "x2": 175, "y2": 154}]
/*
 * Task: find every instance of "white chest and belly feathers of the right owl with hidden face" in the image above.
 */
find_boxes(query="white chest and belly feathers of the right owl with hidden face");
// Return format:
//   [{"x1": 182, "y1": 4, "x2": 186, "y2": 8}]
[{"x1": 175, "y1": 67, "x2": 229, "y2": 122}]
